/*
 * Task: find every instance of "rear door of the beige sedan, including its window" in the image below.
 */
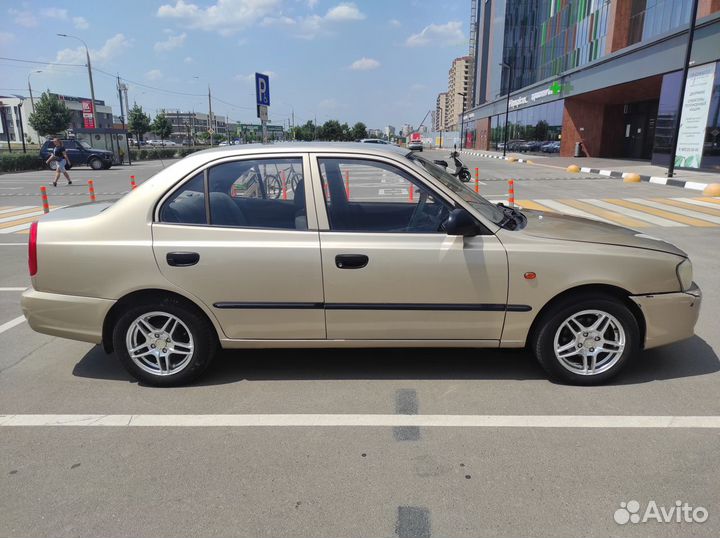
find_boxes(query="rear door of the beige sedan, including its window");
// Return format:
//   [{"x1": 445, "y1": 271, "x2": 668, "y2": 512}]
[{"x1": 153, "y1": 155, "x2": 325, "y2": 340}]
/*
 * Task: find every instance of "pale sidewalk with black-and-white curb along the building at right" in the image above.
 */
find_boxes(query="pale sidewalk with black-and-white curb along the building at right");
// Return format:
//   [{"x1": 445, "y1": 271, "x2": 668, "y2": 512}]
[{"x1": 463, "y1": 150, "x2": 720, "y2": 190}]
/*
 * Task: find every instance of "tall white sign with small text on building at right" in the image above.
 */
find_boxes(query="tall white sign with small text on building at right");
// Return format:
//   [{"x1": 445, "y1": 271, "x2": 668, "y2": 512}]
[{"x1": 675, "y1": 64, "x2": 715, "y2": 168}]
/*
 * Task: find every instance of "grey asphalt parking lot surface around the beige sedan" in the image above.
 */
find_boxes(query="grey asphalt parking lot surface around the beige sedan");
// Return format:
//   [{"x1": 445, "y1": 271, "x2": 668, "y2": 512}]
[{"x1": 0, "y1": 152, "x2": 720, "y2": 538}]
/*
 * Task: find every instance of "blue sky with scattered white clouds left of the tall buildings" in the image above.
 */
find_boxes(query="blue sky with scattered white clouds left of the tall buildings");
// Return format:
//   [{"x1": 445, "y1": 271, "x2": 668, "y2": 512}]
[{"x1": 0, "y1": 0, "x2": 470, "y2": 128}]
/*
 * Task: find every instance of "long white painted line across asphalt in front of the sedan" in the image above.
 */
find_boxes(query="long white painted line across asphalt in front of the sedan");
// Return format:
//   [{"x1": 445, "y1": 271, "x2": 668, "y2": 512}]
[{"x1": 0, "y1": 414, "x2": 720, "y2": 429}]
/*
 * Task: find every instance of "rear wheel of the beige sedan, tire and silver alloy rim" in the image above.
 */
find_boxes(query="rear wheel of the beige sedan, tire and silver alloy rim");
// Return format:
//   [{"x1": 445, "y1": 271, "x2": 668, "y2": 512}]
[{"x1": 113, "y1": 297, "x2": 218, "y2": 387}]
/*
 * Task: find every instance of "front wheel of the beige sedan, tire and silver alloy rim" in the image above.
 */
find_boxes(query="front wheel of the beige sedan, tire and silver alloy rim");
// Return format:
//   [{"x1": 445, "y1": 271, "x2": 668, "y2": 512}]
[{"x1": 531, "y1": 295, "x2": 640, "y2": 385}]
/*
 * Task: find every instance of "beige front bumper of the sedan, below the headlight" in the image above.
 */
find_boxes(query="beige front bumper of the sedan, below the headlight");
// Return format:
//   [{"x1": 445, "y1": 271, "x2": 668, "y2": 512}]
[{"x1": 630, "y1": 282, "x2": 702, "y2": 349}]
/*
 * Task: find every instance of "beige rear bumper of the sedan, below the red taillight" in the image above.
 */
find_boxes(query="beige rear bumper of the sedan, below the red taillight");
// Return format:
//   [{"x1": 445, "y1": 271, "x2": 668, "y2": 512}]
[{"x1": 20, "y1": 288, "x2": 115, "y2": 344}]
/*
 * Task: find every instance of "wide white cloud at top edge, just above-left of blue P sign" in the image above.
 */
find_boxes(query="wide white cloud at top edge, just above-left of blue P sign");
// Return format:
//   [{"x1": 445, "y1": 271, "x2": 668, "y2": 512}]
[{"x1": 157, "y1": 0, "x2": 281, "y2": 35}]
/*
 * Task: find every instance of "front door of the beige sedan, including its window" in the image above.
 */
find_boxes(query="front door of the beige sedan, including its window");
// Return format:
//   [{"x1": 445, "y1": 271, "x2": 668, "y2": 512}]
[{"x1": 316, "y1": 155, "x2": 507, "y2": 340}]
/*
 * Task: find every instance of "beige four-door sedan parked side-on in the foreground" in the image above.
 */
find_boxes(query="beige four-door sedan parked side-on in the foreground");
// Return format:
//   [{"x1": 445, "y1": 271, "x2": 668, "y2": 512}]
[{"x1": 22, "y1": 142, "x2": 701, "y2": 385}]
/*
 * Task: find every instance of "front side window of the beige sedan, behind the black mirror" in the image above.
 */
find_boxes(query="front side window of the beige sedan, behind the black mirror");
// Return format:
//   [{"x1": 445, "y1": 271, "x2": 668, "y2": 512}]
[{"x1": 318, "y1": 158, "x2": 450, "y2": 233}]
